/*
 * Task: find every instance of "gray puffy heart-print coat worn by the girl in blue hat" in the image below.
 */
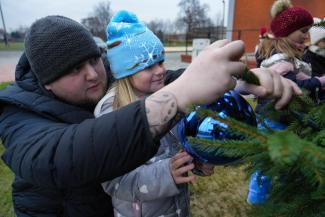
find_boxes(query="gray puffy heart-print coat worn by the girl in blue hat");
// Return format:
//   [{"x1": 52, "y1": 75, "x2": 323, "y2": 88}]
[{"x1": 95, "y1": 90, "x2": 190, "y2": 217}]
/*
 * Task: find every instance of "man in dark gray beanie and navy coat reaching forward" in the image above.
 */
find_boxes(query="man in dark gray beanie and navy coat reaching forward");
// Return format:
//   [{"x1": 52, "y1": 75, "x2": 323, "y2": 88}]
[{"x1": 0, "y1": 16, "x2": 300, "y2": 217}]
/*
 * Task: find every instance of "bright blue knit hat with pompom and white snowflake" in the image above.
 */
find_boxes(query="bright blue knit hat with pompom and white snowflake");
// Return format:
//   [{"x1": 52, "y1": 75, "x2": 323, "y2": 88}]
[{"x1": 106, "y1": 10, "x2": 165, "y2": 79}]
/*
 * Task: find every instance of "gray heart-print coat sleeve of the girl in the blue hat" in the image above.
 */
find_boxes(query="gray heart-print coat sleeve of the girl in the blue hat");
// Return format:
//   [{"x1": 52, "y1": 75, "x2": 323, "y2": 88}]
[{"x1": 102, "y1": 158, "x2": 180, "y2": 202}]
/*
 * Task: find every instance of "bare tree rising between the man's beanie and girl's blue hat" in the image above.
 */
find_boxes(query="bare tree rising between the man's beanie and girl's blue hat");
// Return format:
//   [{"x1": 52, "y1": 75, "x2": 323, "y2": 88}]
[{"x1": 81, "y1": 1, "x2": 113, "y2": 39}]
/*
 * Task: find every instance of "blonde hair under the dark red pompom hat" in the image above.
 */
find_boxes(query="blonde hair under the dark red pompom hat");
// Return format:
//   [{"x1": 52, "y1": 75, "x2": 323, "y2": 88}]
[{"x1": 259, "y1": 38, "x2": 303, "y2": 60}]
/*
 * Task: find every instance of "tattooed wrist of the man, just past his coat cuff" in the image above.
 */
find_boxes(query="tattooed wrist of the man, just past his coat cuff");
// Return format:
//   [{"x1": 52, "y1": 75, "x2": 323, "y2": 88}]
[{"x1": 145, "y1": 91, "x2": 183, "y2": 137}]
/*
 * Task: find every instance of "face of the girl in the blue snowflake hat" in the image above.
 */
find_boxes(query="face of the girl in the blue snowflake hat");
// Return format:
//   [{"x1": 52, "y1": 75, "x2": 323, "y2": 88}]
[{"x1": 130, "y1": 62, "x2": 166, "y2": 97}]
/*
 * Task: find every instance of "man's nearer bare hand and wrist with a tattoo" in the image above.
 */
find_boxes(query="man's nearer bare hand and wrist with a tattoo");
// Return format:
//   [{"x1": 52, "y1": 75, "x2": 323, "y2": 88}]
[{"x1": 145, "y1": 40, "x2": 245, "y2": 136}]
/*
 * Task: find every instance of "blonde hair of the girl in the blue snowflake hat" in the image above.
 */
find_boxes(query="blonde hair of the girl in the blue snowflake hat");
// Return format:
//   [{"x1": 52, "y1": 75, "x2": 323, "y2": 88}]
[{"x1": 113, "y1": 77, "x2": 137, "y2": 110}]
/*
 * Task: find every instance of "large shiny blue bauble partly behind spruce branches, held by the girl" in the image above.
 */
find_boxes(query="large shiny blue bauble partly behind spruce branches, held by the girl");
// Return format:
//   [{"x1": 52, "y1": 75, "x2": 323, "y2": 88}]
[{"x1": 178, "y1": 91, "x2": 256, "y2": 165}]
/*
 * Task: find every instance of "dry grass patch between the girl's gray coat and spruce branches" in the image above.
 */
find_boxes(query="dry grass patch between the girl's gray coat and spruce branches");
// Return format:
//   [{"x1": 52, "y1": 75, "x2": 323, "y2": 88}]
[{"x1": 190, "y1": 166, "x2": 250, "y2": 217}]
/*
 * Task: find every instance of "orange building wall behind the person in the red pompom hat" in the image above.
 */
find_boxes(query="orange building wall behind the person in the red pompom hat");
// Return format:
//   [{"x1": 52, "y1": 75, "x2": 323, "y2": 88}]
[{"x1": 232, "y1": 0, "x2": 325, "y2": 52}]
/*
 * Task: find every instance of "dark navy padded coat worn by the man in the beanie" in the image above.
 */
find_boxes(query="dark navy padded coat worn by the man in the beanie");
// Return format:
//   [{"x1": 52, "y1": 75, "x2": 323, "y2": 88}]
[{"x1": 0, "y1": 54, "x2": 159, "y2": 217}]
